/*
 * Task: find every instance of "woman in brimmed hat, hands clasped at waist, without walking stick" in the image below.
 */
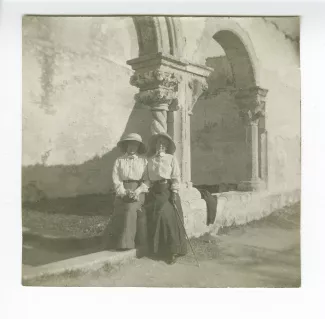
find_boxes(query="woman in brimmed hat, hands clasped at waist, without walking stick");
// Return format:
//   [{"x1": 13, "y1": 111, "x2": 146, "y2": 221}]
[{"x1": 106, "y1": 133, "x2": 148, "y2": 254}]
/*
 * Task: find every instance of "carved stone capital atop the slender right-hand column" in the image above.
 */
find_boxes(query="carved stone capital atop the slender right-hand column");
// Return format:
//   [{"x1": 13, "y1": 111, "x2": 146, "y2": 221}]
[{"x1": 235, "y1": 87, "x2": 268, "y2": 125}]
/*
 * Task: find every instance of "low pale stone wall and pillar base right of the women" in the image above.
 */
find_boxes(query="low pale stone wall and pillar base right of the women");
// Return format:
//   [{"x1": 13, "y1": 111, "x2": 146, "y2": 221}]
[{"x1": 180, "y1": 188, "x2": 300, "y2": 237}]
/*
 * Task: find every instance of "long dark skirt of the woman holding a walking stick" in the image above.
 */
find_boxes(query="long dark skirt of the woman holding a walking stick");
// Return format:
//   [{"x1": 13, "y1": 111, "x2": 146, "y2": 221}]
[{"x1": 145, "y1": 183, "x2": 187, "y2": 257}]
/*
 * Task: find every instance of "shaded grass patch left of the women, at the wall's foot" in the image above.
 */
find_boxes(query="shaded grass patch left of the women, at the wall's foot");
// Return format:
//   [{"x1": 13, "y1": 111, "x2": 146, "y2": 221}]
[{"x1": 22, "y1": 193, "x2": 115, "y2": 238}]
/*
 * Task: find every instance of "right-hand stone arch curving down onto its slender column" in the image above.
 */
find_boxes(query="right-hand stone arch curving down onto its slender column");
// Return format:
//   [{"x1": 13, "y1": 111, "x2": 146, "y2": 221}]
[{"x1": 191, "y1": 18, "x2": 268, "y2": 191}]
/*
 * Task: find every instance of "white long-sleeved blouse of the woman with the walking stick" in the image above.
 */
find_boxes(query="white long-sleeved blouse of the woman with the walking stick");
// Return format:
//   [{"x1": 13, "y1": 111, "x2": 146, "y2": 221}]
[{"x1": 146, "y1": 153, "x2": 180, "y2": 191}]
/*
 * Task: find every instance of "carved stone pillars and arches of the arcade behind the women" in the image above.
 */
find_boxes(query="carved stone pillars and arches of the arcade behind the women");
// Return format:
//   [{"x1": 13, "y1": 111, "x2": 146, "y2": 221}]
[{"x1": 127, "y1": 16, "x2": 267, "y2": 235}]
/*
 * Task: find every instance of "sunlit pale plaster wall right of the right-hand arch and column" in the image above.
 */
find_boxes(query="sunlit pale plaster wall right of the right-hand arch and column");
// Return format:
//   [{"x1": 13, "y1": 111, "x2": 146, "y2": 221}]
[{"x1": 243, "y1": 19, "x2": 301, "y2": 191}]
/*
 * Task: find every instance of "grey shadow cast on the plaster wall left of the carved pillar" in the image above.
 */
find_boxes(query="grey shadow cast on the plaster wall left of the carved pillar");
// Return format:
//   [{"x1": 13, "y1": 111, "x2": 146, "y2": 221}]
[{"x1": 22, "y1": 105, "x2": 151, "y2": 215}]
